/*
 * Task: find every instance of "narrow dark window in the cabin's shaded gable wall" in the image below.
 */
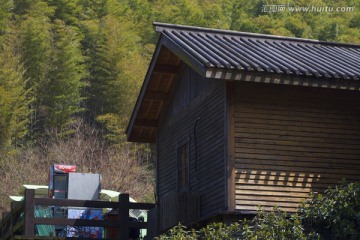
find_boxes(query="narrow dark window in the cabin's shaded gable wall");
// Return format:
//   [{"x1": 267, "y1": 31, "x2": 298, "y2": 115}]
[{"x1": 178, "y1": 144, "x2": 189, "y2": 191}]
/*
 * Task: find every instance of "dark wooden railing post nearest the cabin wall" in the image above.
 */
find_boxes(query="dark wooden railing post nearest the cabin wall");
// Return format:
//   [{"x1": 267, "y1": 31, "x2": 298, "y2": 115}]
[{"x1": 118, "y1": 193, "x2": 129, "y2": 240}]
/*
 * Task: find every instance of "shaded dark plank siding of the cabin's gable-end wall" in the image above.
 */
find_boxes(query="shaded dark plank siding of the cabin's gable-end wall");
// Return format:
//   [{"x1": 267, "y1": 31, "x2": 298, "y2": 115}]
[{"x1": 157, "y1": 66, "x2": 226, "y2": 217}]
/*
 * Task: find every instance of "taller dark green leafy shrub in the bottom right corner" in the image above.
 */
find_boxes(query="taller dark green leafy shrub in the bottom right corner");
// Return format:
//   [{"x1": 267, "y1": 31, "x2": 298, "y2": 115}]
[{"x1": 299, "y1": 181, "x2": 360, "y2": 239}]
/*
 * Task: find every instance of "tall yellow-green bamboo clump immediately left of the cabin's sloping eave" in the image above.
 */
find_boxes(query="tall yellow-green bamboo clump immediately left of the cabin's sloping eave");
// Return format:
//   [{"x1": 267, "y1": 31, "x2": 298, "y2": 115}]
[{"x1": 83, "y1": 16, "x2": 145, "y2": 142}]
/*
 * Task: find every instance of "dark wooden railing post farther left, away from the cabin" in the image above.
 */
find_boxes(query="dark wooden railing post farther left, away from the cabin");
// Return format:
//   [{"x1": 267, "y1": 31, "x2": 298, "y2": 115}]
[{"x1": 24, "y1": 189, "x2": 35, "y2": 237}]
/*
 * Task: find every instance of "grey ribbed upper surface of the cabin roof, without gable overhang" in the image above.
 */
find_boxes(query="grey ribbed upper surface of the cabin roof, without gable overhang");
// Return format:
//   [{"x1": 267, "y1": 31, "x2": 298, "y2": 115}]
[{"x1": 154, "y1": 23, "x2": 360, "y2": 80}]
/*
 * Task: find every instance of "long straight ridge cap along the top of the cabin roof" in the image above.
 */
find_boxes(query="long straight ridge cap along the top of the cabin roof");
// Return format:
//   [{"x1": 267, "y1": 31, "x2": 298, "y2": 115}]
[{"x1": 153, "y1": 22, "x2": 360, "y2": 48}]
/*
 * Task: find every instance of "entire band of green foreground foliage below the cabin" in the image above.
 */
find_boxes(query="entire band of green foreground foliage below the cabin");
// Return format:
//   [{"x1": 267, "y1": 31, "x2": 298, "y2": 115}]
[{"x1": 157, "y1": 181, "x2": 360, "y2": 240}]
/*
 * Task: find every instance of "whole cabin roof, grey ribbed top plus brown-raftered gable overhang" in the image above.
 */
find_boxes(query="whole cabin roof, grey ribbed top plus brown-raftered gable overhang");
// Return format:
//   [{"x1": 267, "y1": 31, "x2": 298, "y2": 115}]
[{"x1": 126, "y1": 23, "x2": 360, "y2": 142}]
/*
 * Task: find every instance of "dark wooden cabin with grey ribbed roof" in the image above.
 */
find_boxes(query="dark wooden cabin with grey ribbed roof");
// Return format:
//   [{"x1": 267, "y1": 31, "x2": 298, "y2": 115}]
[{"x1": 127, "y1": 23, "x2": 360, "y2": 231}]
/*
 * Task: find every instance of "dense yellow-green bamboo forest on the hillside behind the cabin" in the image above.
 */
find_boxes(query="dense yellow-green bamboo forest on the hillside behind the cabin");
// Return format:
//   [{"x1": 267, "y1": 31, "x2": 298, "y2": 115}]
[{"x1": 0, "y1": 0, "x2": 360, "y2": 147}]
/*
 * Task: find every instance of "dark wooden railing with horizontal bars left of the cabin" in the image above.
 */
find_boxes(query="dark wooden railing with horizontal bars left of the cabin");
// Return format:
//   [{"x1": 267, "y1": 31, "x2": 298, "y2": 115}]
[{"x1": 0, "y1": 189, "x2": 155, "y2": 240}]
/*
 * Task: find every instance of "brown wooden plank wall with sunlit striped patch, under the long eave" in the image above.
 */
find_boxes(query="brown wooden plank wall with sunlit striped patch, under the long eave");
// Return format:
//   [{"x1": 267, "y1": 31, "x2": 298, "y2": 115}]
[{"x1": 234, "y1": 82, "x2": 360, "y2": 212}]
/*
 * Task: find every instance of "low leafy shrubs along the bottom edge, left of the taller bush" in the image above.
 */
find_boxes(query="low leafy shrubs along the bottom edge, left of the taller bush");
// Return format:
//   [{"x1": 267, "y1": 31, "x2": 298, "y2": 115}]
[{"x1": 157, "y1": 207, "x2": 319, "y2": 240}]
